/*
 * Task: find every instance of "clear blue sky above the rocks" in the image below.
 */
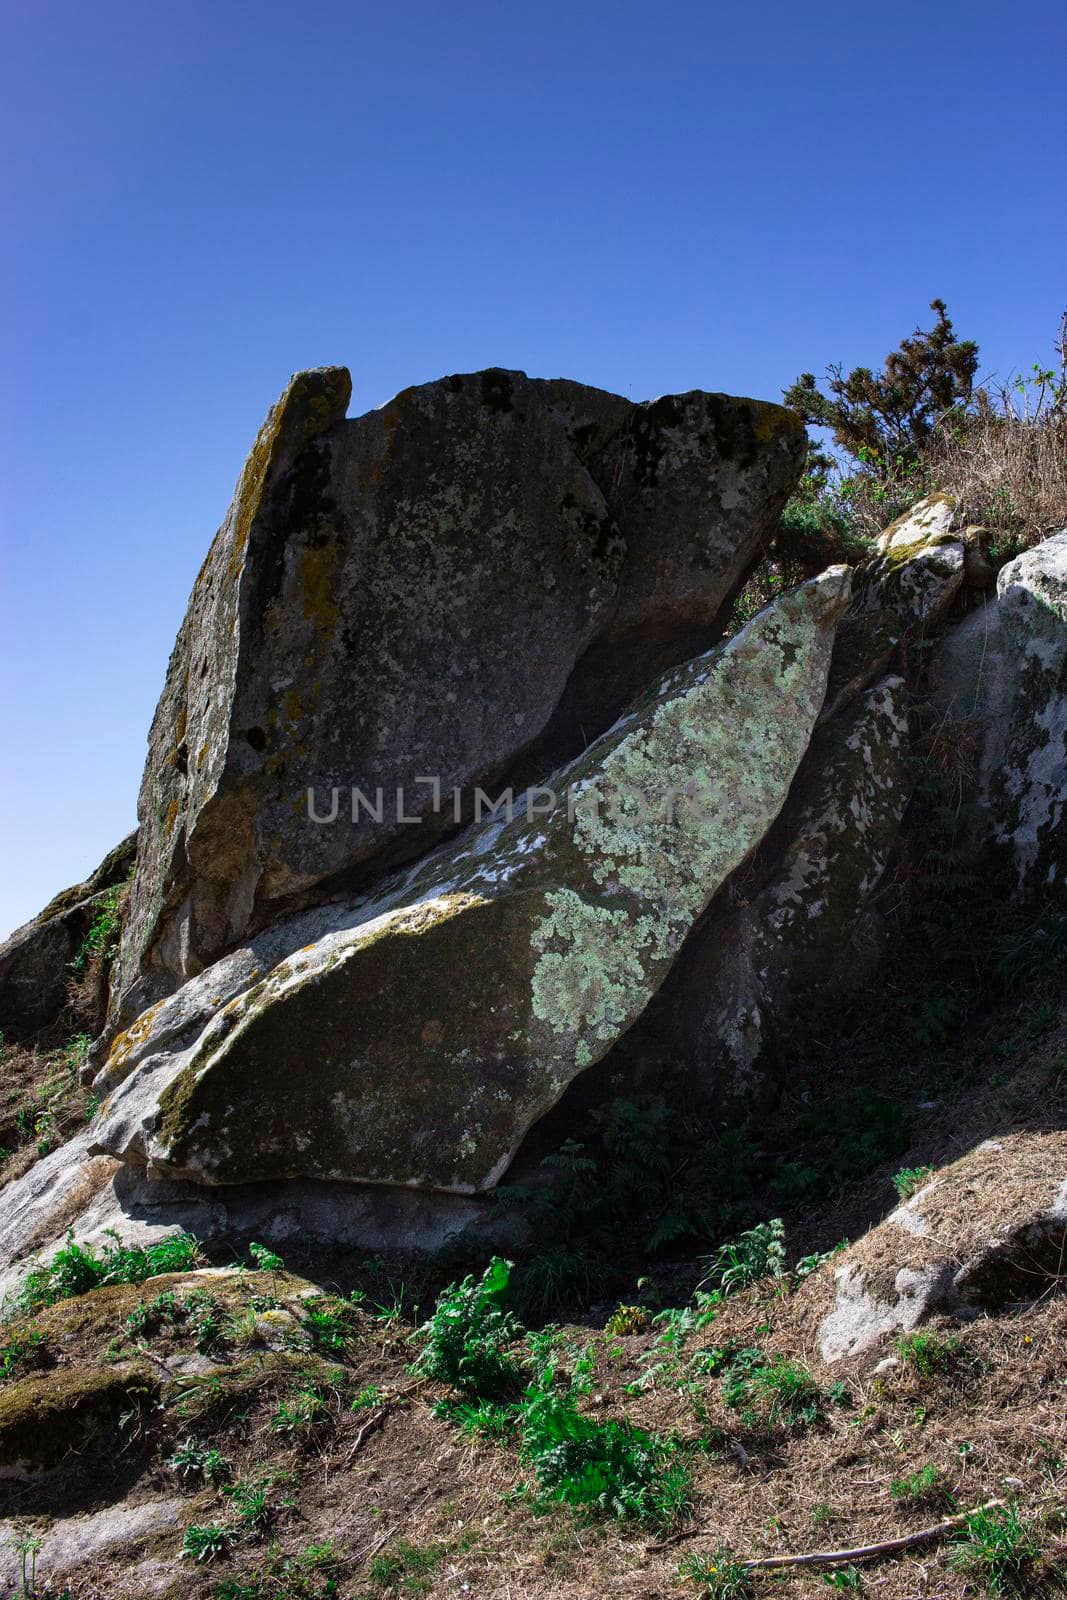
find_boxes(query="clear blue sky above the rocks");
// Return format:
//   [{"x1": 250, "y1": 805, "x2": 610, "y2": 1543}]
[{"x1": 0, "y1": 0, "x2": 1067, "y2": 936}]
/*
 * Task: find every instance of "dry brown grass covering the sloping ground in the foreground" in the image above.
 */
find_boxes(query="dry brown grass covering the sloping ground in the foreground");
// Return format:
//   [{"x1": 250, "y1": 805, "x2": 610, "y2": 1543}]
[{"x1": 5, "y1": 1254, "x2": 1067, "y2": 1600}]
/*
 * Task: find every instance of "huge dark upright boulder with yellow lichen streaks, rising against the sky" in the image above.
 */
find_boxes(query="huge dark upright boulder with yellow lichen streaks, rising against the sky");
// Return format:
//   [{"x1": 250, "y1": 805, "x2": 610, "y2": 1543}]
[{"x1": 114, "y1": 368, "x2": 805, "y2": 1022}]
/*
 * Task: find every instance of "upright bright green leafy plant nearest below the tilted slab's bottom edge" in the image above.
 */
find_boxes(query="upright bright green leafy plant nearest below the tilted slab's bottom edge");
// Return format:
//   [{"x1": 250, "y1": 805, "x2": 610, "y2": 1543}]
[{"x1": 414, "y1": 1256, "x2": 520, "y2": 1400}]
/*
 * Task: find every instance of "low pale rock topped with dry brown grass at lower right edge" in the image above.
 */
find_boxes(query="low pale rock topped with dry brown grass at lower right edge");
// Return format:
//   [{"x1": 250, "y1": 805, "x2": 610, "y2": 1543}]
[{"x1": 819, "y1": 1131, "x2": 1067, "y2": 1362}]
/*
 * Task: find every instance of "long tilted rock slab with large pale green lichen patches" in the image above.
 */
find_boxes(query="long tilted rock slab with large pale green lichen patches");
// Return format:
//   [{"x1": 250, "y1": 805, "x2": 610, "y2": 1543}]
[{"x1": 94, "y1": 568, "x2": 849, "y2": 1194}]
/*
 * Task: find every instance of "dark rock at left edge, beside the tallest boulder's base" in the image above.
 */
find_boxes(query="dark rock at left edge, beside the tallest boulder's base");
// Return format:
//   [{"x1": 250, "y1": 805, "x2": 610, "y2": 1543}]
[{"x1": 0, "y1": 834, "x2": 138, "y2": 1038}]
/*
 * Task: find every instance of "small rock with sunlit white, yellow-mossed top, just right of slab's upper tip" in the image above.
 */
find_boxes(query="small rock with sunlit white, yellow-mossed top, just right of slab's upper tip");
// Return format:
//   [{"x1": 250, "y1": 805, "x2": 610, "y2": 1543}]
[{"x1": 822, "y1": 494, "x2": 966, "y2": 720}]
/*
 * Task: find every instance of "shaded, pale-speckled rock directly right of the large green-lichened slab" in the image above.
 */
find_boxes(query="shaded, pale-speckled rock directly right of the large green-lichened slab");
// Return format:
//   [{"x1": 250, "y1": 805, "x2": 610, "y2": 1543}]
[{"x1": 664, "y1": 677, "x2": 912, "y2": 1102}]
